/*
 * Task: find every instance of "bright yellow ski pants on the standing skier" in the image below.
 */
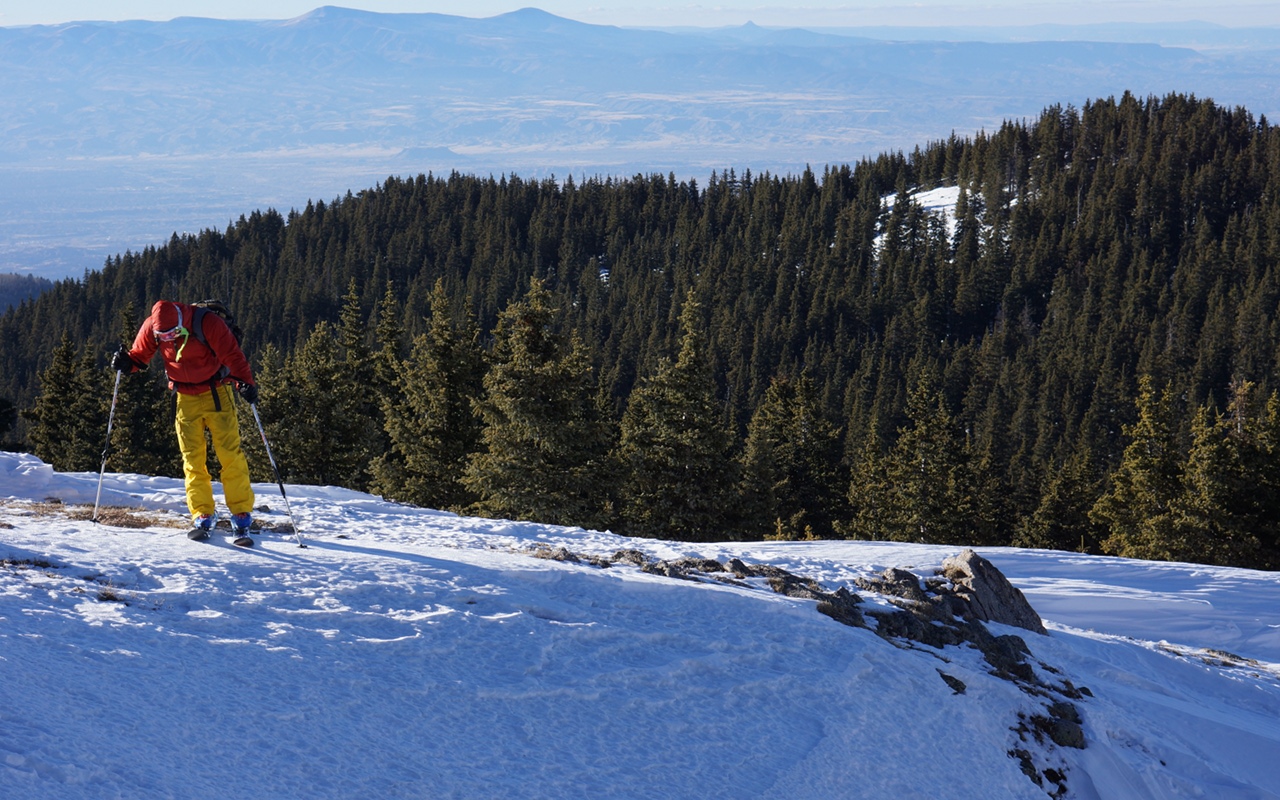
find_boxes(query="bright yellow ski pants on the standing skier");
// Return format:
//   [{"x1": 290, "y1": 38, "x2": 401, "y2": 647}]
[{"x1": 175, "y1": 385, "x2": 253, "y2": 518}]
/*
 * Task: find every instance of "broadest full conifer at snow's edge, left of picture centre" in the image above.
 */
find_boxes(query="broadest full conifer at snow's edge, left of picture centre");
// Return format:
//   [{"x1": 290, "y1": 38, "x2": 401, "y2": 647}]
[{"x1": 462, "y1": 279, "x2": 609, "y2": 526}]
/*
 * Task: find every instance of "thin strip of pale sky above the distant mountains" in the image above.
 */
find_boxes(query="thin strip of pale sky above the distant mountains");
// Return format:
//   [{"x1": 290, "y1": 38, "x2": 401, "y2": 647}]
[{"x1": 0, "y1": 0, "x2": 1280, "y2": 27}]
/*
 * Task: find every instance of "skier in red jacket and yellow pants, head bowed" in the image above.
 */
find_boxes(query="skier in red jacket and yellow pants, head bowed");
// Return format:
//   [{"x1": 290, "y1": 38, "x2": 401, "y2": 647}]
[{"x1": 111, "y1": 300, "x2": 257, "y2": 547}]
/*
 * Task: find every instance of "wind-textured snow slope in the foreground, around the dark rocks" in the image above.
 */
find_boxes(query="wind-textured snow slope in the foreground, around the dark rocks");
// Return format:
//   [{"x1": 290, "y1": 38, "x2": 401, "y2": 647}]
[{"x1": 0, "y1": 453, "x2": 1280, "y2": 799}]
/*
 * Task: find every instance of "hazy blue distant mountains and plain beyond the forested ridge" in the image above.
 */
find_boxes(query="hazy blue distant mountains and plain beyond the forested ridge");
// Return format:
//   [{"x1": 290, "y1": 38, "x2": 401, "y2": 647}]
[{"x1": 0, "y1": 6, "x2": 1280, "y2": 276}]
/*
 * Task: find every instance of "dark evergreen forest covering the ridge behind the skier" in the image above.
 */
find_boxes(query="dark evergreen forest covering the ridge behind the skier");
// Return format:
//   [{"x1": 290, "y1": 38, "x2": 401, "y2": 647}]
[{"x1": 0, "y1": 95, "x2": 1280, "y2": 568}]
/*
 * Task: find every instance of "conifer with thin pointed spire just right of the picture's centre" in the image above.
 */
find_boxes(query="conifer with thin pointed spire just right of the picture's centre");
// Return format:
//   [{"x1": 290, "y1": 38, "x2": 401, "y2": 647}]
[{"x1": 617, "y1": 294, "x2": 736, "y2": 541}]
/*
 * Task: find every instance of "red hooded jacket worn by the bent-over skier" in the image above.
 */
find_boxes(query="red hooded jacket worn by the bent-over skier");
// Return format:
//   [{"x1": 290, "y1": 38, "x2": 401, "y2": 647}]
[{"x1": 129, "y1": 300, "x2": 253, "y2": 394}]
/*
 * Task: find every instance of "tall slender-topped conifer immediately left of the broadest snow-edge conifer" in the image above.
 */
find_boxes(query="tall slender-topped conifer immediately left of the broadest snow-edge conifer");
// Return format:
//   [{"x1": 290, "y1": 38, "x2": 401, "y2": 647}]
[{"x1": 374, "y1": 282, "x2": 484, "y2": 511}]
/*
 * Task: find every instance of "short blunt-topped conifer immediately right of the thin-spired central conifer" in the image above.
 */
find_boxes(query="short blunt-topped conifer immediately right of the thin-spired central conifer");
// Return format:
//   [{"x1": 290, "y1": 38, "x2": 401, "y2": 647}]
[{"x1": 740, "y1": 376, "x2": 844, "y2": 539}]
